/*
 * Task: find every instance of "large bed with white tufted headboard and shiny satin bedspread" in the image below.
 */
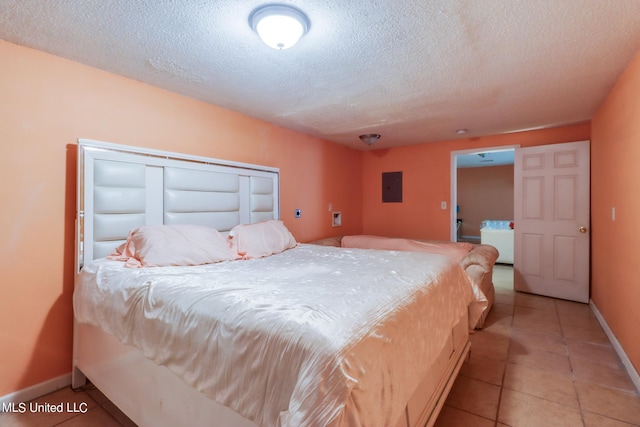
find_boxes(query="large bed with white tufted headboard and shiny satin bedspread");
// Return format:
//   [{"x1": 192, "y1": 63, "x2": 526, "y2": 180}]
[{"x1": 72, "y1": 140, "x2": 472, "y2": 427}]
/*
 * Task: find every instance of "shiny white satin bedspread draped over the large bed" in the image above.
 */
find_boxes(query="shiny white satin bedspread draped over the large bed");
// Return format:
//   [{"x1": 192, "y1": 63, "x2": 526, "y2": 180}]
[{"x1": 74, "y1": 245, "x2": 472, "y2": 427}]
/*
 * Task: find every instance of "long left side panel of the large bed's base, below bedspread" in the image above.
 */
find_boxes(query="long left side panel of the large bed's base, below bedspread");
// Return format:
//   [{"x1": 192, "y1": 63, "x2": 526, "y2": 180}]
[{"x1": 72, "y1": 324, "x2": 257, "y2": 427}]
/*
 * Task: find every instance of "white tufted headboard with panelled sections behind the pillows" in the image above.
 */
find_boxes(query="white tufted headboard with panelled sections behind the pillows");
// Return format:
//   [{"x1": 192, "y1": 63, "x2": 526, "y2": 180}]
[{"x1": 76, "y1": 139, "x2": 280, "y2": 271}]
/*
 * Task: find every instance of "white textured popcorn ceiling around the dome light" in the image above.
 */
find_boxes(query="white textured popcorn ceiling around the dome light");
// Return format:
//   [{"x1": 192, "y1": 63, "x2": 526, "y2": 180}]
[{"x1": 0, "y1": 0, "x2": 640, "y2": 149}]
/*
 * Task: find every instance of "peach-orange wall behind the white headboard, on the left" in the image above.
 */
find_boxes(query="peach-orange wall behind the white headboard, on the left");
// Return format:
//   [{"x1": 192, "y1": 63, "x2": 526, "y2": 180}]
[{"x1": 0, "y1": 41, "x2": 362, "y2": 396}]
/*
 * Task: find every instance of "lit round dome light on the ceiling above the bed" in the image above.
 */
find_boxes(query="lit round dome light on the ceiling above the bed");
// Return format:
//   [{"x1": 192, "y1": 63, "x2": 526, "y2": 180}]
[{"x1": 249, "y1": 4, "x2": 310, "y2": 50}]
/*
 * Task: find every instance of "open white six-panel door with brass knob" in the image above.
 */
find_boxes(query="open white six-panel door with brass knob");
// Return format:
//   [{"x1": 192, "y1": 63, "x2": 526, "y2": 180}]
[{"x1": 513, "y1": 141, "x2": 590, "y2": 303}]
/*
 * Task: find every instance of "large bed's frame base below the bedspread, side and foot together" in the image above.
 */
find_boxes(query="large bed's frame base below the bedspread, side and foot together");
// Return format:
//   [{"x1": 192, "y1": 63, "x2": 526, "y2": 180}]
[{"x1": 72, "y1": 316, "x2": 470, "y2": 427}]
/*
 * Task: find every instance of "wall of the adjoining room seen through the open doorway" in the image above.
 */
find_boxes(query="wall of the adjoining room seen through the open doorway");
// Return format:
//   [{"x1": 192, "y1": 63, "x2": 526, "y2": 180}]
[{"x1": 457, "y1": 165, "x2": 513, "y2": 239}]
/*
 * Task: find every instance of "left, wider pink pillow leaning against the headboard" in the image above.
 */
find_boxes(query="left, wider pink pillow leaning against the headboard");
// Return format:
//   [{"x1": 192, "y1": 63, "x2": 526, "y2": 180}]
[{"x1": 107, "y1": 225, "x2": 237, "y2": 267}]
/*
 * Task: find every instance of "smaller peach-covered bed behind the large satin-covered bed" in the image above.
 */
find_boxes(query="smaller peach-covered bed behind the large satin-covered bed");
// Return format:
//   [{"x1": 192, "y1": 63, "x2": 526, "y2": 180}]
[{"x1": 312, "y1": 236, "x2": 499, "y2": 329}]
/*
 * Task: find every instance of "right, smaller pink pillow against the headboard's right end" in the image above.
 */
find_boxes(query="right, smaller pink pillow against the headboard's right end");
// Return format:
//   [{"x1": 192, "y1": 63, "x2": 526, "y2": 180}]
[{"x1": 229, "y1": 220, "x2": 297, "y2": 259}]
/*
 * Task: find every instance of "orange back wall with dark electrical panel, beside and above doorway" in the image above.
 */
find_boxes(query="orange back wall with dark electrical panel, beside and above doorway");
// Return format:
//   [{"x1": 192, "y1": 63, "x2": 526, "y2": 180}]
[{"x1": 362, "y1": 123, "x2": 590, "y2": 240}]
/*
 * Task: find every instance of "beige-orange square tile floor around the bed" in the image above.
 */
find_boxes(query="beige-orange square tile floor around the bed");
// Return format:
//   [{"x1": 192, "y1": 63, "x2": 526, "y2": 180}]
[{"x1": 0, "y1": 266, "x2": 640, "y2": 427}]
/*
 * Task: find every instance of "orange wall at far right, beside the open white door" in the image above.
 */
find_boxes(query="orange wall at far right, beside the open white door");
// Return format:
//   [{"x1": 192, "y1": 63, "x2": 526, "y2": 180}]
[{"x1": 591, "y1": 50, "x2": 640, "y2": 371}]
